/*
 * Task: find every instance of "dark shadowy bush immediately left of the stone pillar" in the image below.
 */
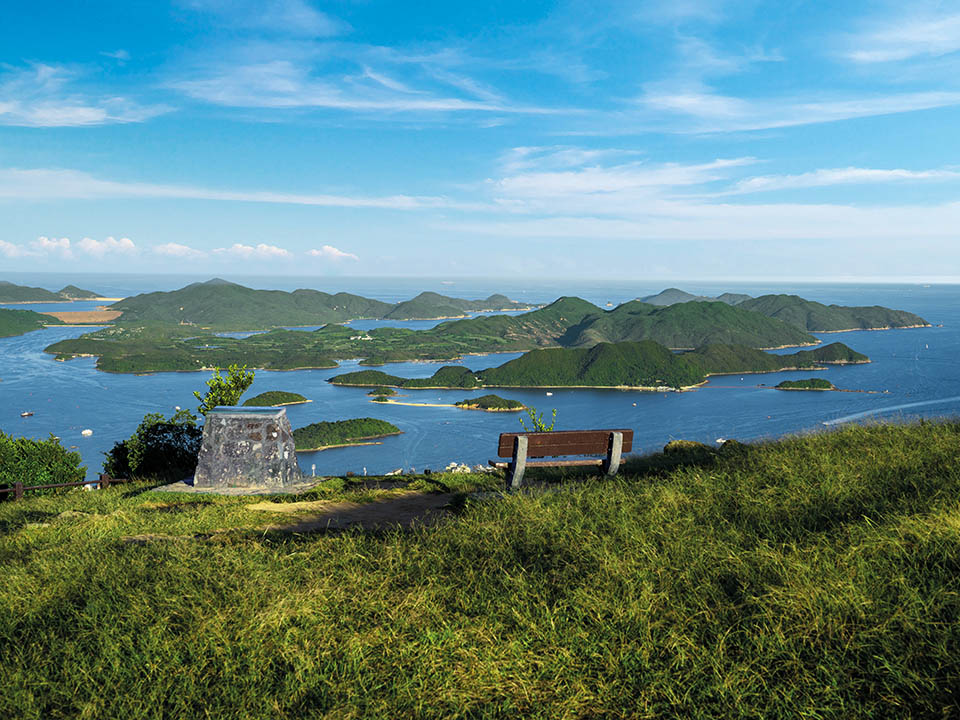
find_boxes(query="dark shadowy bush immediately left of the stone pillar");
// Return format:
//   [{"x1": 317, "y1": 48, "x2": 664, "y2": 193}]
[{"x1": 103, "y1": 410, "x2": 203, "y2": 482}]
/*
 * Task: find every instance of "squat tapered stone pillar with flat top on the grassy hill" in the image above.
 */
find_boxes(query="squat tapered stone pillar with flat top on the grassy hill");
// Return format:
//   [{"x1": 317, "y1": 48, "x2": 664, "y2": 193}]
[{"x1": 193, "y1": 407, "x2": 300, "y2": 489}]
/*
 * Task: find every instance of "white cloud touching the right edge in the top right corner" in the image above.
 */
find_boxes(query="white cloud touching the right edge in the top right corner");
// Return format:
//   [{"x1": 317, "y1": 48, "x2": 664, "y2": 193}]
[{"x1": 847, "y1": 13, "x2": 960, "y2": 63}]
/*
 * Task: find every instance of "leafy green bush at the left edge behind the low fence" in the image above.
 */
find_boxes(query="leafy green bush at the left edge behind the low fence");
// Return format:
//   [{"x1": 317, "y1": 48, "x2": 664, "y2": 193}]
[{"x1": 0, "y1": 431, "x2": 87, "y2": 497}]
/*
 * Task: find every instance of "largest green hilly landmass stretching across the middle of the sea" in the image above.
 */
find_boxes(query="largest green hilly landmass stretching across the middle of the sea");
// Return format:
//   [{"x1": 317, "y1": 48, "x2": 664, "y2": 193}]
[{"x1": 37, "y1": 281, "x2": 928, "y2": 373}]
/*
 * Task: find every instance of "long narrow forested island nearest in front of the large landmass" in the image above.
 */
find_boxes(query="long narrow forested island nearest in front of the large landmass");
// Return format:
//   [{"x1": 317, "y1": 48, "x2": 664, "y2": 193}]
[{"x1": 329, "y1": 340, "x2": 870, "y2": 390}]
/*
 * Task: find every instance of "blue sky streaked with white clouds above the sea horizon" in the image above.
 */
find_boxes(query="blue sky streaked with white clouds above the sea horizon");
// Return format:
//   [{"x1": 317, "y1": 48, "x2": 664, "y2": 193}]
[{"x1": 0, "y1": 0, "x2": 960, "y2": 281}]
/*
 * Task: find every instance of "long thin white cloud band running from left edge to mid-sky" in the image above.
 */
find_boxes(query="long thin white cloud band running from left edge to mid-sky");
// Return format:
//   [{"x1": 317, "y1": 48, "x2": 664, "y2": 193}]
[{"x1": 0, "y1": 168, "x2": 478, "y2": 210}]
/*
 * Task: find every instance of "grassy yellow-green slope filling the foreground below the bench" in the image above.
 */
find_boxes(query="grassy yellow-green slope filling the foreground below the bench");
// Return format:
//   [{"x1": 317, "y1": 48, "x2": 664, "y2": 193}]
[{"x1": 0, "y1": 422, "x2": 960, "y2": 718}]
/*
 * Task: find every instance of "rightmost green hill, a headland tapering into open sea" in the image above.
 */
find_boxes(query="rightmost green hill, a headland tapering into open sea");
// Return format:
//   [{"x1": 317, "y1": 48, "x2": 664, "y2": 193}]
[{"x1": 739, "y1": 295, "x2": 930, "y2": 332}]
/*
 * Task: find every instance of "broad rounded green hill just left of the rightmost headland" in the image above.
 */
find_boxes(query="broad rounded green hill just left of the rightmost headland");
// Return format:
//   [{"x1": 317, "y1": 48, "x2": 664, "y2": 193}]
[{"x1": 558, "y1": 301, "x2": 817, "y2": 348}]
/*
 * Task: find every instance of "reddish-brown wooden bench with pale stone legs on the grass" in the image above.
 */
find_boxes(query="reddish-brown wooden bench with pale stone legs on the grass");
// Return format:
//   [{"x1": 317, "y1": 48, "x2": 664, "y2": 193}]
[{"x1": 490, "y1": 428, "x2": 633, "y2": 489}]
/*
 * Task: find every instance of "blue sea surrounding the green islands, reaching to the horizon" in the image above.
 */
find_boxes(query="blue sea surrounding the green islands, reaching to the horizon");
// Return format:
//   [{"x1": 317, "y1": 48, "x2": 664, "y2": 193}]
[{"x1": 0, "y1": 273, "x2": 960, "y2": 477}]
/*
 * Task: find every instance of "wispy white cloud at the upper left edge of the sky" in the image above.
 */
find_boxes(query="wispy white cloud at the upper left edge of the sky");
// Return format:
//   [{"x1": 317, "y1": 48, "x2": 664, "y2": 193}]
[{"x1": 0, "y1": 63, "x2": 170, "y2": 127}]
